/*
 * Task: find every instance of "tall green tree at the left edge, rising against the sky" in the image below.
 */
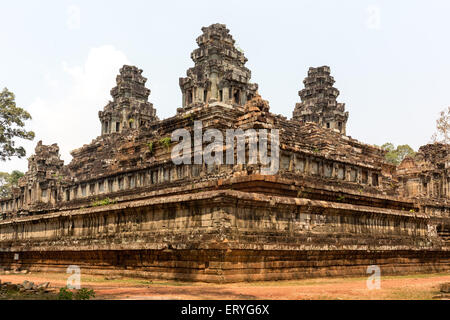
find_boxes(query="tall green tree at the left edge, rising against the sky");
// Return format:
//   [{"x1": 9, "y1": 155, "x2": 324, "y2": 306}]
[{"x1": 0, "y1": 88, "x2": 34, "y2": 161}]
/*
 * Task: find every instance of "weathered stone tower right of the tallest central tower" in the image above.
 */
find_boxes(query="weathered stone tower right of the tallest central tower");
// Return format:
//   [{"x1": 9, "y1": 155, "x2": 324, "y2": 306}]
[{"x1": 292, "y1": 66, "x2": 348, "y2": 135}]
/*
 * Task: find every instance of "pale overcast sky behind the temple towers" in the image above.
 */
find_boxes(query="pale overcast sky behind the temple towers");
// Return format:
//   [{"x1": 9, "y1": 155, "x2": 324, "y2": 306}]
[{"x1": 0, "y1": 0, "x2": 450, "y2": 175}]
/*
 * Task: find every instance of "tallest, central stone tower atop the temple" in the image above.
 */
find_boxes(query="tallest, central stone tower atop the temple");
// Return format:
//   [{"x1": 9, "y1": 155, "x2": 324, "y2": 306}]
[{"x1": 178, "y1": 24, "x2": 258, "y2": 113}]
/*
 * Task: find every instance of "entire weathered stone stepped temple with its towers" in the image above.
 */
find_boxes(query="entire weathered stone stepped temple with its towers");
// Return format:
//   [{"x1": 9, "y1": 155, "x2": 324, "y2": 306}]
[{"x1": 0, "y1": 24, "x2": 450, "y2": 282}]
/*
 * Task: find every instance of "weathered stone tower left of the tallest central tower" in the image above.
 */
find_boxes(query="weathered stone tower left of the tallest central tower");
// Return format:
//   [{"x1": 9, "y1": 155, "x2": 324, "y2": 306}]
[{"x1": 98, "y1": 65, "x2": 158, "y2": 135}]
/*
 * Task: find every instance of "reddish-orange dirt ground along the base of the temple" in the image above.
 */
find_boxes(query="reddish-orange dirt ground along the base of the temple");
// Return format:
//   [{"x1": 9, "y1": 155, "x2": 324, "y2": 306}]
[{"x1": 0, "y1": 273, "x2": 450, "y2": 300}]
